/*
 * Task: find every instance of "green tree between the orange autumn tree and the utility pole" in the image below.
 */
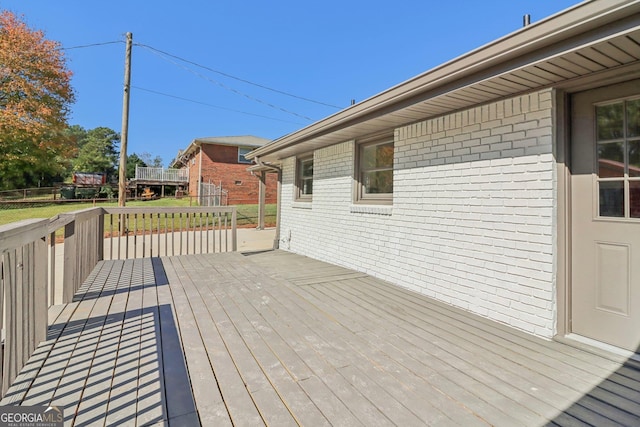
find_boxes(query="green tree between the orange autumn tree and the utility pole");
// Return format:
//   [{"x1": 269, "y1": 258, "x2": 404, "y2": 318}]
[{"x1": 73, "y1": 127, "x2": 120, "y2": 179}]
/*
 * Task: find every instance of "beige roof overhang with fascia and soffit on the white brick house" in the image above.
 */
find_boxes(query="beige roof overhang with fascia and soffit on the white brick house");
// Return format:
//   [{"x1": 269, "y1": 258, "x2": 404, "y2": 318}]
[{"x1": 246, "y1": 0, "x2": 640, "y2": 163}]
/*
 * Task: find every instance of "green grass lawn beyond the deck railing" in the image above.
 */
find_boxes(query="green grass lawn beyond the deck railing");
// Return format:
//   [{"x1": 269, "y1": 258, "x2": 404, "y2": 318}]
[{"x1": 0, "y1": 198, "x2": 276, "y2": 227}]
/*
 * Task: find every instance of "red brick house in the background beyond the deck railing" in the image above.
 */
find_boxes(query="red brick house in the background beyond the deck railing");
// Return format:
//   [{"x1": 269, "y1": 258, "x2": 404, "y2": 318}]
[{"x1": 171, "y1": 136, "x2": 277, "y2": 205}]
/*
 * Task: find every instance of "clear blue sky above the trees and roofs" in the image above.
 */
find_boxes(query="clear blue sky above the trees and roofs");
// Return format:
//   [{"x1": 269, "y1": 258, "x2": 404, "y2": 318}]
[{"x1": 0, "y1": 0, "x2": 579, "y2": 165}]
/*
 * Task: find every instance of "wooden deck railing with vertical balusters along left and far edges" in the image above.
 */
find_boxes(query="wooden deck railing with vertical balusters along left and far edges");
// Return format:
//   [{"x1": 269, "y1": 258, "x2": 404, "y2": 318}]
[{"x1": 0, "y1": 206, "x2": 237, "y2": 397}]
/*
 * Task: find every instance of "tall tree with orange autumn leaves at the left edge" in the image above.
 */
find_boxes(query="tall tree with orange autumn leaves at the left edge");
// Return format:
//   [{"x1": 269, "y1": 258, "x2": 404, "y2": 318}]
[{"x1": 0, "y1": 11, "x2": 75, "y2": 188}]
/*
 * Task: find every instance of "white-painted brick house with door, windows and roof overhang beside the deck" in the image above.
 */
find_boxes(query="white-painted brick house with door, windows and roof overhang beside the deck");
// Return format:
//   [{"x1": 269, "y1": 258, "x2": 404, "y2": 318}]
[{"x1": 248, "y1": 0, "x2": 640, "y2": 351}]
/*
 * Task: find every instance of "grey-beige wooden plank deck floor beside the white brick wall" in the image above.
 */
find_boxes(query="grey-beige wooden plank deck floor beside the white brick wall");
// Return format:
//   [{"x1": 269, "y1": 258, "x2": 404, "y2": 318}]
[{"x1": 0, "y1": 251, "x2": 640, "y2": 426}]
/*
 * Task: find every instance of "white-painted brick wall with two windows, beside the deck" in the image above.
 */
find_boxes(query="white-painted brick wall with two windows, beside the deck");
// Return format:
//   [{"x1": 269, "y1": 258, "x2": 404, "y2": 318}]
[{"x1": 281, "y1": 90, "x2": 555, "y2": 337}]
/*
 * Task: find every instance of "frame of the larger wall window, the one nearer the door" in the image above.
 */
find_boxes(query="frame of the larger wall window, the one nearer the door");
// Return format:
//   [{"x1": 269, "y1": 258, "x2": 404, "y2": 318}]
[{"x1": 353, "y1": 134, "x2": 395, "y2": 205}]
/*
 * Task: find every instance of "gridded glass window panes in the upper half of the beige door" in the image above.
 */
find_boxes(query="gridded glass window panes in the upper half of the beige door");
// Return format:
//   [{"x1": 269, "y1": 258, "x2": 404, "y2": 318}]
[{"x1": 596, "y1": 99, "x2": 640, "y2": 219}]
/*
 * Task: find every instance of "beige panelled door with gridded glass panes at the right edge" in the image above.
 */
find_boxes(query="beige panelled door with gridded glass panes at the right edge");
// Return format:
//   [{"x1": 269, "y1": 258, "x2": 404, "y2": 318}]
[{"x1": 571, "y1": 80, "x2": 640, "y2": 351}]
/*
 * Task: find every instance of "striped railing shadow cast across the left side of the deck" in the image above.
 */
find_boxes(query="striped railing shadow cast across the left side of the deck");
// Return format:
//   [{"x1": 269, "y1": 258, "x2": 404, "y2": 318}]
[{"x1": 0, "y1": 258, "x2": 200, "y2": 425}]
